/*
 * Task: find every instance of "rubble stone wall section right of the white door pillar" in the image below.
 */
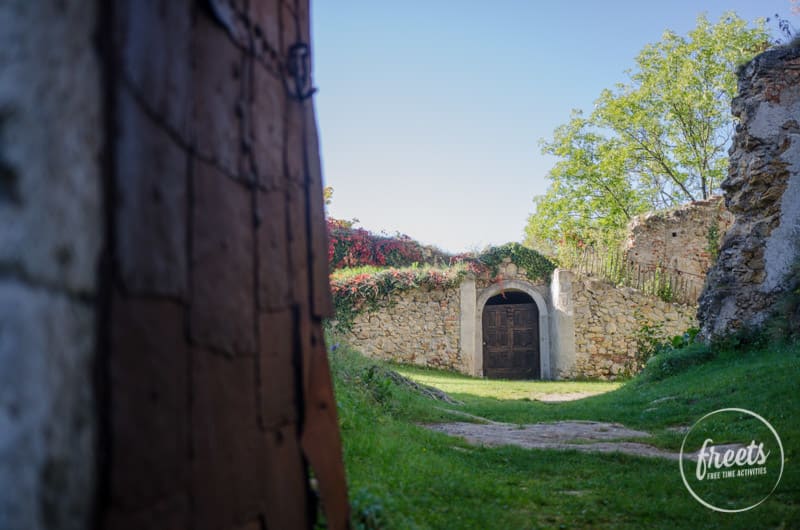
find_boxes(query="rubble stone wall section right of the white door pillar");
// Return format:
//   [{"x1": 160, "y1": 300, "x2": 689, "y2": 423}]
[{"x1": 559, "y1": 276, "x2": 697, "y2": 379}]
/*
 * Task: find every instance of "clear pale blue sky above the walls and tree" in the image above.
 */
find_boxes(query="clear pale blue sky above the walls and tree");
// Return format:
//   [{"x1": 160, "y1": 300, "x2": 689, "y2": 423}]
[{"x1": 312, "y1": 0, "x2": 800, "y2": 252}]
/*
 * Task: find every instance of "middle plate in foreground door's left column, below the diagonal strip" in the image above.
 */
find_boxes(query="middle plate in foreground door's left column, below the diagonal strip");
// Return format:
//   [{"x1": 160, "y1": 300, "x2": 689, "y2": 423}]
[{"x1": 115, "y1": 88, "x2": 189, "y2": 297}]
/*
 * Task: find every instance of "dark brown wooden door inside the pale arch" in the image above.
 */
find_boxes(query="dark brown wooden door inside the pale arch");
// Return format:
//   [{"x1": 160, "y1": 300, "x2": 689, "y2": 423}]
[{"x1": 481, "y1": 291, "x2": 542, "y2": 379}]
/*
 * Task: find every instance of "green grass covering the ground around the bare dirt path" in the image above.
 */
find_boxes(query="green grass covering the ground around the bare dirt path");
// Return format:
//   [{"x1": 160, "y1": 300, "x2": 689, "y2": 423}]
[{"x1": 331, "y1": 336, "x2": 800, "y2": 529}]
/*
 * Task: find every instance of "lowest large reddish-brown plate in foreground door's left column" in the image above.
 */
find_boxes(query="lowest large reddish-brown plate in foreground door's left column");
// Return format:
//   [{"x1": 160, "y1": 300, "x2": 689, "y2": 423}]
[{"x1": 109, "y1": 294, "x2": 189, "y2": 512}]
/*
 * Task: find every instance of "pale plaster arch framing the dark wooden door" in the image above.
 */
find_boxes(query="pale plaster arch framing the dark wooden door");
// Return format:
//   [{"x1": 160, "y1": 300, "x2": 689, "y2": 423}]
[{"x1": 473, "y1": 280, "x2": 550, "y2": 379}]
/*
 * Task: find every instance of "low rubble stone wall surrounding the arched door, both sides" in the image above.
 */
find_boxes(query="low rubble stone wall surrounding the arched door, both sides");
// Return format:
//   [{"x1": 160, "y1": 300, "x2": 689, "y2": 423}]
[{"x1": 344, "y1": 267, "x2": 697, "y2": 379}]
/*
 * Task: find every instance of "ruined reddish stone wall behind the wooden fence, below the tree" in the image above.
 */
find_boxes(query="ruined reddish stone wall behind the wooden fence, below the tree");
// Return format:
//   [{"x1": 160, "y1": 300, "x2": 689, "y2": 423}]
[{"x1": 624, "y1": 197, "x2": 733, "y2": 282}]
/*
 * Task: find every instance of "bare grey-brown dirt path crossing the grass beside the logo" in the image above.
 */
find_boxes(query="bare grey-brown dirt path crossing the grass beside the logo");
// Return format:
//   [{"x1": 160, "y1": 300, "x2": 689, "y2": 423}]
[{"x1": 424, "y1": 417, "x2": 678, "y2": 460}]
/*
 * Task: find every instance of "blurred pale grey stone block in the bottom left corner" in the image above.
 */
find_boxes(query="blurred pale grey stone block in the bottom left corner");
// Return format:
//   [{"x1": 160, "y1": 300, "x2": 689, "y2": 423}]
[{"x1": 0, "y1": 280, "x2": 96, "y2": 529}]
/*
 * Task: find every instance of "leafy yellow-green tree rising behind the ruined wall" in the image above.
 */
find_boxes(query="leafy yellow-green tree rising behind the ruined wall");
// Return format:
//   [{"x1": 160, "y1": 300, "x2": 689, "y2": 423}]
[{"x1": 526, "y1": 13, "x2": 769, "y2": 252}]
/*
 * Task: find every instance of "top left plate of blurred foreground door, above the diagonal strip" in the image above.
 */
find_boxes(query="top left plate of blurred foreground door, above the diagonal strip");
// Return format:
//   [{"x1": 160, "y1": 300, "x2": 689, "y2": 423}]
[{"x1": 114, "y1": 0, "x2": 193, "y2": 143}]
